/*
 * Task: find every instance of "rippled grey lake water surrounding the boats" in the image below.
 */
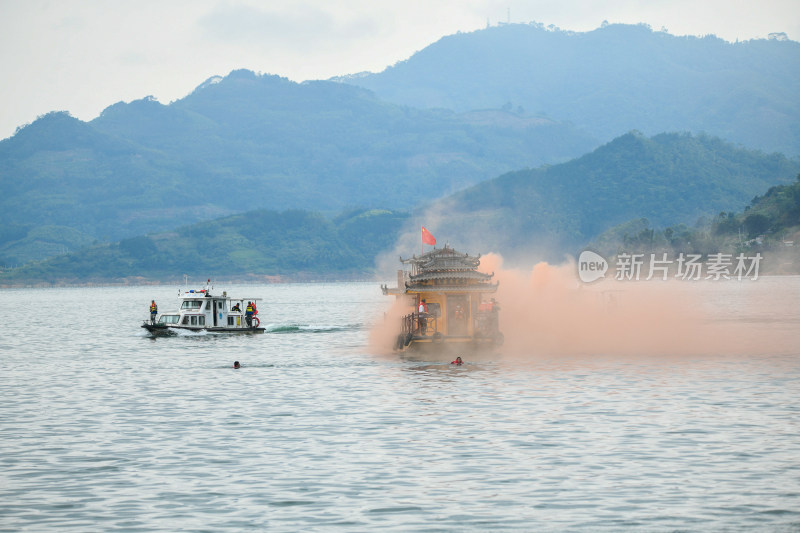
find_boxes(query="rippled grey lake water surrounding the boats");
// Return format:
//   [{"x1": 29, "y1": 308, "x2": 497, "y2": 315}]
[{"x1": 0, "y1": 278, "x2": 800, "y2": 532}]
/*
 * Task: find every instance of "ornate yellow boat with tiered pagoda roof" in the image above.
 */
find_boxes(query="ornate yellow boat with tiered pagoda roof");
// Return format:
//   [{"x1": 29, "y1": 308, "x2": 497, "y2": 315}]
[{"x1": 381, "y1": 246, "x2": 503, "y2": 353}]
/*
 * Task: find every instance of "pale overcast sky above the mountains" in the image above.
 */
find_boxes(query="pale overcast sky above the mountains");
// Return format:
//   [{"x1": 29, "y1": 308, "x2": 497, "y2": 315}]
[{"x1": 0, "y1": 0, "x2": 800, "y2": 139}]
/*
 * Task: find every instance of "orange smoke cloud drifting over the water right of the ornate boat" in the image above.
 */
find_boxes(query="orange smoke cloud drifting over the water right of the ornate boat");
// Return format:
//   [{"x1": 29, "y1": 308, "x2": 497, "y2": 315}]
[{"x1": 480, "y1": 254, "x2": 800, "y2": 357}]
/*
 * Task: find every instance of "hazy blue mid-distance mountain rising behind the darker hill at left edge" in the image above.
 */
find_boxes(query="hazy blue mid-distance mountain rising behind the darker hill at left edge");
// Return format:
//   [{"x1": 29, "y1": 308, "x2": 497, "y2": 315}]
[{"x1": 91, "y1": 70, "x2": 596, "y2": 212}]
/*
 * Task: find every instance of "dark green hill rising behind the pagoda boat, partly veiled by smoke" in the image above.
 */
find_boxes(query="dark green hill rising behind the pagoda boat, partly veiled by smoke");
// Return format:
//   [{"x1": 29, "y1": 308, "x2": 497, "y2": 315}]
[{"x1": 418, "y1": 132, "x2": 800, "y2": 259}]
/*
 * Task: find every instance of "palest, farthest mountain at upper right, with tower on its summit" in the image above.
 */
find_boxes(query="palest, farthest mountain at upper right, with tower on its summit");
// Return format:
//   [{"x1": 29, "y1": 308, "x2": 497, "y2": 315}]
[{"x1": 337, "y1": 24, "x2": 800, "y2": 155}]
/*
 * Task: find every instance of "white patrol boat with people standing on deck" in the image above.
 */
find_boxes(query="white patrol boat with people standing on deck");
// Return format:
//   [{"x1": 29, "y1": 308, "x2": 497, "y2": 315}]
[{"x1": 142, "y1": 287, "x2": 264, "y2": 334}]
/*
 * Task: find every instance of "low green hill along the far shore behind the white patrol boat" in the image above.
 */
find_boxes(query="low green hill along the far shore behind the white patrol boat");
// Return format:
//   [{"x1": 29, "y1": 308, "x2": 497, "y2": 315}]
[{"x1": 0, "y1": 209, "x2": 408, "y2": 286}]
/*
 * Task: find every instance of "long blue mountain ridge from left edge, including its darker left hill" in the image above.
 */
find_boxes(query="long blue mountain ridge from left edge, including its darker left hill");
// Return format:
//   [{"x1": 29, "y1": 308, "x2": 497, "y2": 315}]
[{"x1": 0, "y1": 71, "x2": 595, "y2": 263}]
